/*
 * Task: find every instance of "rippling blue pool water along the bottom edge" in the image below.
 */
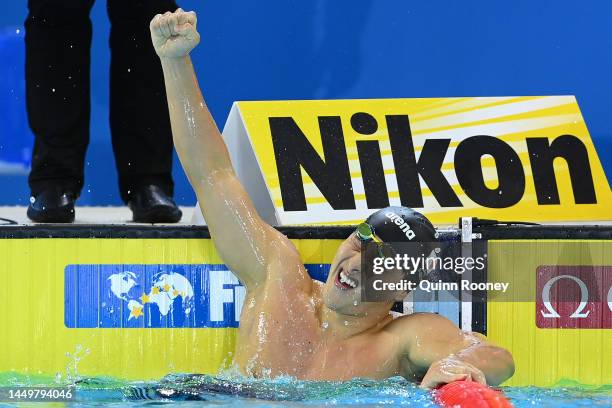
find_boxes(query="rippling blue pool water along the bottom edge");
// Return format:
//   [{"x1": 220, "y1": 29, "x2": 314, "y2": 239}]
[{"x1": 0, "y1": 373, "x2": 612, "y2": 407}]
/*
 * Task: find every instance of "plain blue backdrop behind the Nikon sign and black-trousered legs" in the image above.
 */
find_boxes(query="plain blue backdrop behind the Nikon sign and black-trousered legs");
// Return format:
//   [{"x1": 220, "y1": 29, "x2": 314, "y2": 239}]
[{"x1": 0, "y1": 0, "x2": 612, "y2": 205}]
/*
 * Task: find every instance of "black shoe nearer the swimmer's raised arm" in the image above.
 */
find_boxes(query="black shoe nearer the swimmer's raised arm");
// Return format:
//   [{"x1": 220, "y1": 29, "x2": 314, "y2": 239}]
[{"x1": 128, "y1": 185, "x2": 183, "y2": 224}]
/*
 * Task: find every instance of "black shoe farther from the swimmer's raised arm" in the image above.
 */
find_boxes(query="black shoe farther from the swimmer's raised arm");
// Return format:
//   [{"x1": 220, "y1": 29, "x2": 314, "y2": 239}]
[{"x1": 28, "y1": 187, "x2": 77, "y2": 223}]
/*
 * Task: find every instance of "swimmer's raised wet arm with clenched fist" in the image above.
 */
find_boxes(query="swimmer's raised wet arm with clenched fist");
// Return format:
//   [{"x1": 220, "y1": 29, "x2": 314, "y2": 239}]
[{"x1": 150, "y1": 9, "x2": 300, "y2": 288}]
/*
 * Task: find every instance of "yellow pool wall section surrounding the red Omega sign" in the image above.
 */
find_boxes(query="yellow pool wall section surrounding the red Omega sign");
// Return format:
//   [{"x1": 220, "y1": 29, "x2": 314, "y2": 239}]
[{"x1": 487, "y1": 240, "x2": 612, "y2": 386}]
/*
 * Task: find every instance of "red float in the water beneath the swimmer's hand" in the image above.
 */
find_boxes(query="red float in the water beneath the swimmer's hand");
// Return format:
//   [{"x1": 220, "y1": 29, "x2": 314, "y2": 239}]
[{"x1": 434, "y1": 381, "x2": 512, "y2": 408}]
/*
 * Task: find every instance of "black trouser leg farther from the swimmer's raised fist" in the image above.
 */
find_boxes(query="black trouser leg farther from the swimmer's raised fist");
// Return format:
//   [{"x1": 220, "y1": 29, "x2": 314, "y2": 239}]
[{"x1": 25, "y1": 0, "x2": 93, "y2": 197}]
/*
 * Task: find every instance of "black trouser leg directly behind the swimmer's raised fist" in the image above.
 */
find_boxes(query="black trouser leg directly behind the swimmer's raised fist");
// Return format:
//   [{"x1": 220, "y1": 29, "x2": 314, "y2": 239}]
[{"x1": 108, "y1": 0, "x2": 177, "y2": 202}]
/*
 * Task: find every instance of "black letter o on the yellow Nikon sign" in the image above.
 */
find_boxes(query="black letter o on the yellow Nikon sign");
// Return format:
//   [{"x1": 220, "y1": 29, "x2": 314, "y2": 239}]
[{"x1": 455, "y1": 135, "x2": 525, "y2": 208}]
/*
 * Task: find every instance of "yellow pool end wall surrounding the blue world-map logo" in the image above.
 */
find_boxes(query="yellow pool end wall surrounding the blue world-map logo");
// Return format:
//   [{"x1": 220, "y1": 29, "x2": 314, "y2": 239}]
[{"x1": 0, "y1": 238, "x2": 341, "y2": 380}]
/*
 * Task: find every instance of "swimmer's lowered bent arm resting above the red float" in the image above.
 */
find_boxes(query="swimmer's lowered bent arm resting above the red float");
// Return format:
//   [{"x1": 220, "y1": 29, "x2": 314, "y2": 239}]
[{"x1": 388, "y1": 313, "x2": 514, "y2": 388}]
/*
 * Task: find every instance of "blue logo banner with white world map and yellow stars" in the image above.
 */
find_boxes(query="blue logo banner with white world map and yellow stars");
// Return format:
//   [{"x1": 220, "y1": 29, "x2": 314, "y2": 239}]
[{"x1": 64, "y1": 264, "x2": 246, "y2": 328}]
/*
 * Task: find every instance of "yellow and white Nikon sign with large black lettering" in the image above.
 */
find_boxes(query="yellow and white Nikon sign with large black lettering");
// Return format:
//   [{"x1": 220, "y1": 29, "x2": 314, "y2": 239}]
[{"x1": 218, "y1": 96, "x2": 612, "y2": 225}]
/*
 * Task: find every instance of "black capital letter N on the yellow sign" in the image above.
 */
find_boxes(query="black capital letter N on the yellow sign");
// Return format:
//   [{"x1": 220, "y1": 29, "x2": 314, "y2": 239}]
[{"x1": 269, "y1": 116, "x2": 355, "y2": 211}]
